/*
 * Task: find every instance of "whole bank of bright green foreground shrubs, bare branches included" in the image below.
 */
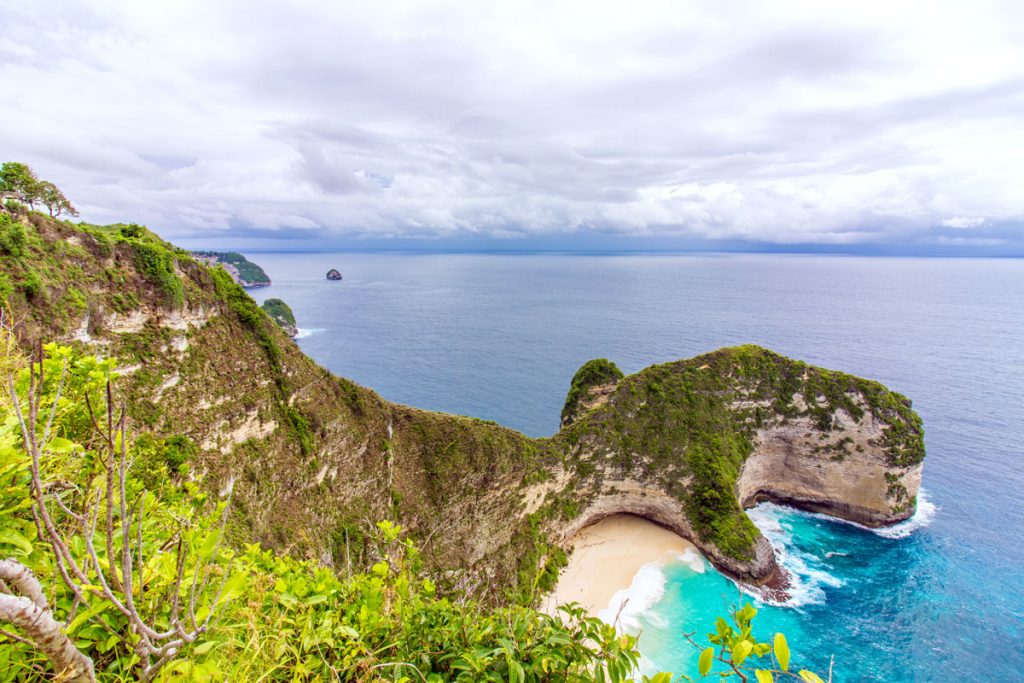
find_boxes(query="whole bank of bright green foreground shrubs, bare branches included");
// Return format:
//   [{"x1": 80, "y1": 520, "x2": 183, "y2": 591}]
[{"x1": 0, "y1": 342, "x2": 664, "y2": 682}]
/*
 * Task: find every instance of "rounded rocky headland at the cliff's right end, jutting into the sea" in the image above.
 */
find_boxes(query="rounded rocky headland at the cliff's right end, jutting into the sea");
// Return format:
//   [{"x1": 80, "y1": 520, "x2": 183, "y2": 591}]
[{"x1": 540, "y1": 346, "x2": 924, "y2": 586}]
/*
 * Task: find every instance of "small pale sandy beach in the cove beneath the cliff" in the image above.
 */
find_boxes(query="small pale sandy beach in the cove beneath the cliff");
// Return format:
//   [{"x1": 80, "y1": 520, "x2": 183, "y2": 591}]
[{"x1": 544, "y1": 514, "x2": 699, "y2": 615}]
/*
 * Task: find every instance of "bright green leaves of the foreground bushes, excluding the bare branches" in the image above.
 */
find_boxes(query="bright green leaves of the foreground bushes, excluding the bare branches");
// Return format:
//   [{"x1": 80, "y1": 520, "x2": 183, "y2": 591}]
[{"x1": 0, "y1": 345, "x2": 671, "y2": 683}]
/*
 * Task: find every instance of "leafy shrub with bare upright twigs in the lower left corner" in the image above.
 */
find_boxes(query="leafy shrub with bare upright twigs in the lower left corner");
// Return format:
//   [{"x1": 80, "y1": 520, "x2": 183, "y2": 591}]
[{"x1": 0, "y1": 327, "x2": 229, "y2": 683}]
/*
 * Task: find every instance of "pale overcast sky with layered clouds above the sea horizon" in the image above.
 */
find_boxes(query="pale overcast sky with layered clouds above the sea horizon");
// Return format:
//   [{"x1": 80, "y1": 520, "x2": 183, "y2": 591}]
[{"x1": 0, "y1": 0, "x2": 1024, "y2": 255}]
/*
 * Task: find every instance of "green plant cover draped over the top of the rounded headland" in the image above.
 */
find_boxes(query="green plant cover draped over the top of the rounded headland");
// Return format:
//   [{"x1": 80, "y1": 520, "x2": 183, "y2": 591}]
[{"x1": 556, "y1": 345, "x2": 924, "y2": 560}]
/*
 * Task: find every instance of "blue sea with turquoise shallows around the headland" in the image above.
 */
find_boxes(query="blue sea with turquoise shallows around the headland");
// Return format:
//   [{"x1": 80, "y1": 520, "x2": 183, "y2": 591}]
[{"x1": 249, "y1": 253, "x2": 1024, "y2": 683}]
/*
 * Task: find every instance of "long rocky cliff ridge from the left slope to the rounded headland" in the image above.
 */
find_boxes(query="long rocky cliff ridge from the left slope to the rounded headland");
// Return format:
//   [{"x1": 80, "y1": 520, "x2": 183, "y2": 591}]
[{"x1": 0, "y1": 215, "x2": 924, "y2": 603}]
